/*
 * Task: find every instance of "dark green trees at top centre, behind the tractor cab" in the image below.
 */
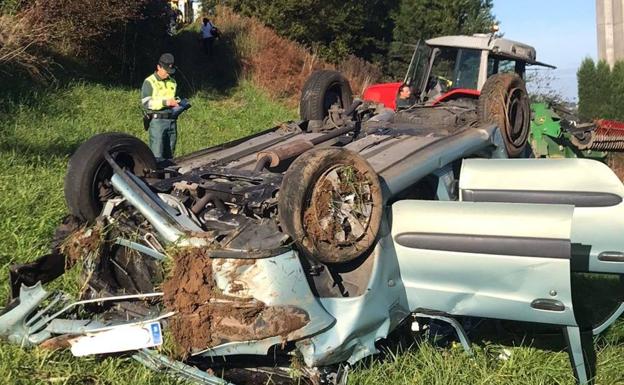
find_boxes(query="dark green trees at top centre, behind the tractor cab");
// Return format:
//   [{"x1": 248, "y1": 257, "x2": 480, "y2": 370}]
[{"x1": 222, "y1": 0, "x2": 495, "y2": 77}]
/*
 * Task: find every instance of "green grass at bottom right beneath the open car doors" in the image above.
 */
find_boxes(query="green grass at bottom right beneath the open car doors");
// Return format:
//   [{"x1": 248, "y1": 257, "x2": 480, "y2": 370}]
[{"x1": 349, "y1": 322, "x2": 624, "y2": 385}]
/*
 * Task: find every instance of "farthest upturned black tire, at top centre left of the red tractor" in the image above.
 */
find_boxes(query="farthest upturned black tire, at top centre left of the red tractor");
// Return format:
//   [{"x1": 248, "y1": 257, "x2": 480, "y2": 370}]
[{"x1": 299, "y1": 70, "x2": 353, "y2": 120}]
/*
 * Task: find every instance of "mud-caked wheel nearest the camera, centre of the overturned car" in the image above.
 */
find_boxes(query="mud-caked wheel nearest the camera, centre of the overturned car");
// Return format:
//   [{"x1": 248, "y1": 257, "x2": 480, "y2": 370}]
[{"x1": 278, "y1": 148, "x2": 382, "y2": 263}]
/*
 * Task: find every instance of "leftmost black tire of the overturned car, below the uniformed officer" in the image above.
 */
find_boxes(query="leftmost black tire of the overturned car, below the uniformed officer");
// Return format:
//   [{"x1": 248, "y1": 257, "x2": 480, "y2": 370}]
[{"x1": 65, "y1": 132, "x2": 156, "y2": 222}]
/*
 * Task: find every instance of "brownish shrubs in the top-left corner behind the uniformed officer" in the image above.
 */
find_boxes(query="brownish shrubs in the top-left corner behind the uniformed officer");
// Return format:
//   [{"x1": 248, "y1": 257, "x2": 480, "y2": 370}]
[{"x1": 0, "y1": 0, "x2": 170, "y2": 80}]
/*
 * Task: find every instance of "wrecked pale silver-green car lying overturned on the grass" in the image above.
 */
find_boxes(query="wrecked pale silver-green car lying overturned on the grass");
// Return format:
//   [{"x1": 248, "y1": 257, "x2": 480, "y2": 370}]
[{"x1": 0, "y1": 71, "x2": 624, "y2": 384}]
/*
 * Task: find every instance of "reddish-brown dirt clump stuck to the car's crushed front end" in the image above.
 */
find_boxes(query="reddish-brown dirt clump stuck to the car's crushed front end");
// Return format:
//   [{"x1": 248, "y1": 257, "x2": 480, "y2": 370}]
[{"x1": 163, "y1": 248, "x2": 309, "y2": 357}]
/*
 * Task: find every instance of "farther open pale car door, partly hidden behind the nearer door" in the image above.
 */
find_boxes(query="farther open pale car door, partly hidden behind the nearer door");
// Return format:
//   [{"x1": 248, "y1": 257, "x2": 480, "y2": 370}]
[{"x1": 459, "y1": 159, "x2": 624, "y2": 274}]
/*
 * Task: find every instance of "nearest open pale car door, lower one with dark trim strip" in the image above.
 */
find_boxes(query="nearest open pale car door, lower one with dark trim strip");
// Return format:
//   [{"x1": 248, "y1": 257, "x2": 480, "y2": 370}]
[{"x1": 392, "y1": 200, "x2": 576, "y2": 325}]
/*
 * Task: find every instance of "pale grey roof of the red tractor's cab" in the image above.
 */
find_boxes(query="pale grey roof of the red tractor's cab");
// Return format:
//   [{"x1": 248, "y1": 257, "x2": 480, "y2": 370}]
[{"x1": 426, "y1": 33, "x2": 554, "y2": 68}]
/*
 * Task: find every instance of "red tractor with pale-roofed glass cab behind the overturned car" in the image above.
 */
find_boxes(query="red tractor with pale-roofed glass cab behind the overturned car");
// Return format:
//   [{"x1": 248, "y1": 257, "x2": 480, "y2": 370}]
[{"x1": 363, "y1": 34, "x2": 554, "y2": 109}]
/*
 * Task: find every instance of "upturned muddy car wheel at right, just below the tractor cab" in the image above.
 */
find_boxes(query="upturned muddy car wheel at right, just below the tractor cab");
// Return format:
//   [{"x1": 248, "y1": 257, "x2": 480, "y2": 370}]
[{"x1": 478, "y1": 74, "x2": 531, "y2": 158}]
